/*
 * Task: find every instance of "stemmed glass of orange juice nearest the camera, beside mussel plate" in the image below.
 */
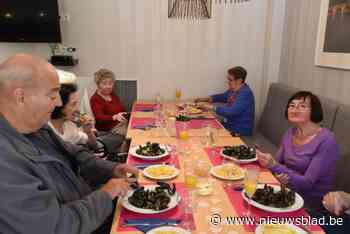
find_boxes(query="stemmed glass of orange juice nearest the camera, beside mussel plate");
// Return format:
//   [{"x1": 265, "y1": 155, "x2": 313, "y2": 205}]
[{"x1": 244, "y1": 166, "x2": 260, "y2": 217}]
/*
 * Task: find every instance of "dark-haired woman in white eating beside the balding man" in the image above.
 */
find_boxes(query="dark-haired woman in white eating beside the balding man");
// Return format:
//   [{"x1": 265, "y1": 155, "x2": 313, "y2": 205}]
[{"x1": 49, "y1": 83, "x2": 97, "y2": 149}]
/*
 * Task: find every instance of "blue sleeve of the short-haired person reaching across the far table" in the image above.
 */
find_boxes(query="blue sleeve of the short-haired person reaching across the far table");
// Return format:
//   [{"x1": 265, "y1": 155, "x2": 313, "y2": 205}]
[{"x1": 215, "y1": 90, "x2": 254, "y2": 118}]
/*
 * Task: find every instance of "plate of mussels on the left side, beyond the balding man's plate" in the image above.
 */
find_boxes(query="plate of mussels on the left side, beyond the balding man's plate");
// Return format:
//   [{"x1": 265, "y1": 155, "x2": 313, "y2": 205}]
[{"x1": 130, "y1": 142, "x2": 169, "y2": 160}]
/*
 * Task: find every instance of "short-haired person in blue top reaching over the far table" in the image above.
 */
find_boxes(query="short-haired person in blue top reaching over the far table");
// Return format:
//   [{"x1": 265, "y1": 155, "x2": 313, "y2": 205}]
[{"x1": 195, "y1": 67, "x2": 255, "y2": 136}]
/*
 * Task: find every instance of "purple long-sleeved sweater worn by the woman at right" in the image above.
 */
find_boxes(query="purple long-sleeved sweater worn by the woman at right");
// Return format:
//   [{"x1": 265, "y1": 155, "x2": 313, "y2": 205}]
[{"x1": 270, "y1": 128, "x2": 339, "y2": 209}]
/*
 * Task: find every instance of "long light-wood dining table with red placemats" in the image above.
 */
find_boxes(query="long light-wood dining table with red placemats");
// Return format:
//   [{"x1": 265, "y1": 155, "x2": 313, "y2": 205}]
[{"x1": 110, "y1": 101, "x2": 324, "y2": 234}]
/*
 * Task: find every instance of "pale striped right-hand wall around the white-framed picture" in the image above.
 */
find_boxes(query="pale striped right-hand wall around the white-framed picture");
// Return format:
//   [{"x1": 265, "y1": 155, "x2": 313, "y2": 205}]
[{"x1": 280, "y1": 0, "x2": 350, "y2": 105}]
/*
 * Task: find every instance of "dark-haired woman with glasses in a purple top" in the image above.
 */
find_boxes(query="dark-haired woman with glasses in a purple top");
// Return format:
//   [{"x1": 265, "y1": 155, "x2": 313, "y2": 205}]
[{"x1": 257, "y1": 91, "x2": 339, "y2": 210}]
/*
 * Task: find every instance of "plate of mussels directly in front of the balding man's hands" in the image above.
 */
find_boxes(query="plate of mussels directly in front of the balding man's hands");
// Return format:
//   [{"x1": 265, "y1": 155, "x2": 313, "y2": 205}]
[{"x1": 122, "y1": 182, "x2": 181, "y2": 214}]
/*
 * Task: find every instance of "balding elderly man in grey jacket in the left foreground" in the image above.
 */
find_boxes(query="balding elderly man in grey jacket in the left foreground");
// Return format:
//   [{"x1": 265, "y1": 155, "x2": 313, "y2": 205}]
[{"x1": 0, "y1": 54, "x2": 138, "y2": 234}]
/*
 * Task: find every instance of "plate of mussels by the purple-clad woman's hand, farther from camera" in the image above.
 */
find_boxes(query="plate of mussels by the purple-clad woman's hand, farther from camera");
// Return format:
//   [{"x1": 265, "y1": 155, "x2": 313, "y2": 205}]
[{"x1": 221, "y1": 145, "x2": 257, "y2": 164}]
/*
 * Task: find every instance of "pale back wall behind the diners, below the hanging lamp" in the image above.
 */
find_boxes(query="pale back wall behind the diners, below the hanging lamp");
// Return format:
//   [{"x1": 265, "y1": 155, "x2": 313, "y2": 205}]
[{"x1": 0, "y1": 0, "x2": 285, "y2": 113}]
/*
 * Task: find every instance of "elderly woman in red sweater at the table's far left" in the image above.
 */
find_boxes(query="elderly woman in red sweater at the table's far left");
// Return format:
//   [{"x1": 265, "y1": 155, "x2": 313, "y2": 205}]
[{"x1": 90, "y1": 69, "x2": 127, "y2": 135}]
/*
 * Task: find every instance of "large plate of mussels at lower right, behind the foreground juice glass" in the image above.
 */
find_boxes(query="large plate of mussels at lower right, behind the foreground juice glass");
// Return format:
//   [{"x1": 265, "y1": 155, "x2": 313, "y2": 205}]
[{"x1": 242, "y1": 184, "x2": 304, "y2": 213}]
